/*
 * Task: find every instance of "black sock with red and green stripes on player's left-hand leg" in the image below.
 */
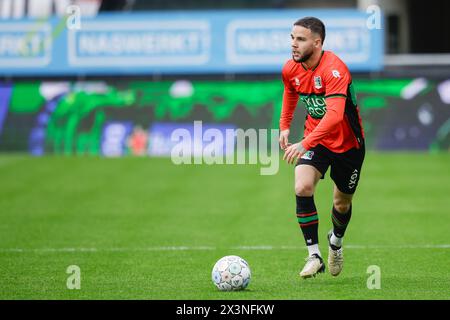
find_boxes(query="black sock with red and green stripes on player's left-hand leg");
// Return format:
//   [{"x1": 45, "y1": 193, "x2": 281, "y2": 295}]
[{"x1": 296, "y1": 195, "x2": 319, "y2": 246}]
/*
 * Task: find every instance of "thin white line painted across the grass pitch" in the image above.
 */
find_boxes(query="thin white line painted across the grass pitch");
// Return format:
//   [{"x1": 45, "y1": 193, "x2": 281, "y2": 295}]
[{"x1": 0, "y1": 244, "x2": 450, "y2": 253}]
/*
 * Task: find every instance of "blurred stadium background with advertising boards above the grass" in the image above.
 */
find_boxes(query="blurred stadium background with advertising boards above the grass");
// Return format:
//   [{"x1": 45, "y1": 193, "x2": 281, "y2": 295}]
[{"x1": 0, "y1": 0, "x2": 450, "y2": 152}]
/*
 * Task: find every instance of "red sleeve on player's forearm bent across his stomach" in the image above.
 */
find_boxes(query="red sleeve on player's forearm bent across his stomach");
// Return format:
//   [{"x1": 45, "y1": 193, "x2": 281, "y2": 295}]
[{"x1": 301, "y1": 95, "x2": 345, "y2": 150}]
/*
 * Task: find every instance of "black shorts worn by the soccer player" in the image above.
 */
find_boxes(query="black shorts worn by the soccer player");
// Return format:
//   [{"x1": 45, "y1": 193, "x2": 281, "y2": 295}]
[{"x1": 296, "y1": 144, "x2": 365, "y2": 194}]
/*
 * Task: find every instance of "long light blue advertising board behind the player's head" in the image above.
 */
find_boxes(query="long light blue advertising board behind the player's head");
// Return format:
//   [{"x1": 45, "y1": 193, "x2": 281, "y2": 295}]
[{"x1": 0, "y1": 9, "x2": 384, "y2": 75}]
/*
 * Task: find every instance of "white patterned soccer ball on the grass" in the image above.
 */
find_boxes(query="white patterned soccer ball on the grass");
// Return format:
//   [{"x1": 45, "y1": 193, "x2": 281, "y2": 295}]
[{"x1": 211, "y1": 256, "x2": 251, "y2": 291}]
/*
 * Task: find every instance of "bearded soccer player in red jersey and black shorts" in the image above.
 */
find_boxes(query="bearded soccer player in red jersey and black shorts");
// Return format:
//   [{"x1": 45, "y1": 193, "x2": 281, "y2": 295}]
[{"x1": 280, "y1": 17, "x2": 365, "y2": 278}]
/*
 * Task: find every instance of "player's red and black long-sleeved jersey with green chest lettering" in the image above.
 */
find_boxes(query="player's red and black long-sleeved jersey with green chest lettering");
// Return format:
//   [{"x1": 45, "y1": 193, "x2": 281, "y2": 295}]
[{"x1": 280, "y1": 51, "x2": 364, "y2": 153}]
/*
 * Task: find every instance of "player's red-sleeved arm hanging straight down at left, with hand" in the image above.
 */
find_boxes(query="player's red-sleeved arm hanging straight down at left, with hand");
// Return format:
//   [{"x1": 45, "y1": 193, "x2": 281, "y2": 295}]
[{"x1": 280, "y1": 66, "x2": 299, "y2": 150}]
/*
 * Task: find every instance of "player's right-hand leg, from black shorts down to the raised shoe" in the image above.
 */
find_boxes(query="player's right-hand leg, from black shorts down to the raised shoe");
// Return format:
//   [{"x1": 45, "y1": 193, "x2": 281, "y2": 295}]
[{"x1": 328, "y1": 148, "x2": 364, "y2": 276}]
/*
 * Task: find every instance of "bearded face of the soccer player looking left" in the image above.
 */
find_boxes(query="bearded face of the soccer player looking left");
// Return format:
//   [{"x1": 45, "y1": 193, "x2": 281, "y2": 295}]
[{"x1": 291, "y1": 26, "x2": 320, "y2": 62}]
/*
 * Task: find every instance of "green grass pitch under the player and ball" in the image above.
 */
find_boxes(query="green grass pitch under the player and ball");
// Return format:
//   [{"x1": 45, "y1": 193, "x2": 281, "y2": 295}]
[{"x1": 0, "y1": 152, "x2": 450, "y2": 299}]
